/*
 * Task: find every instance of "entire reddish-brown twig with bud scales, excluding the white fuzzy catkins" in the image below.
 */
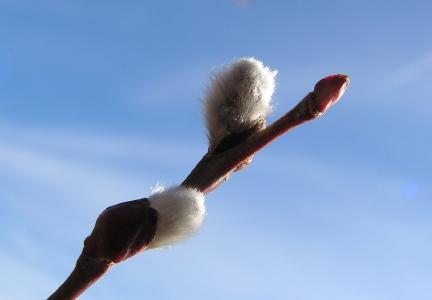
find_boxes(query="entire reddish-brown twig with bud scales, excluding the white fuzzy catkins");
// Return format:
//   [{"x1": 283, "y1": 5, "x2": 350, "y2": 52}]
[{"x1": 48, "y1": 74, "x2": 349, "y2": 300}]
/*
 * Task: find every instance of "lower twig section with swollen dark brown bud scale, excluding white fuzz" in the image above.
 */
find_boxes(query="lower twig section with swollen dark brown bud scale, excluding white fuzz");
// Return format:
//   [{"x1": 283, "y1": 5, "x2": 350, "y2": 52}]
[{"x1": 48, "y1": 198, "x2": 158, "y2": 300}]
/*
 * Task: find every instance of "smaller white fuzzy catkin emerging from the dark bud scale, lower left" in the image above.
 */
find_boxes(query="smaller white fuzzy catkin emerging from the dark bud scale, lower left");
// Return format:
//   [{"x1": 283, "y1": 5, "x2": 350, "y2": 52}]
[{"x1": 147, "y1": 186, "x2": 205, "y2": 249}]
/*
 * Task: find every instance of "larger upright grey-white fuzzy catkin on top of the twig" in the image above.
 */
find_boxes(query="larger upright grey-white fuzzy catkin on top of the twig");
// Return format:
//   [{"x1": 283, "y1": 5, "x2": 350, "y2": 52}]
[{"x1": 203, "y1": 58, "x2": 277, "y2": 151}]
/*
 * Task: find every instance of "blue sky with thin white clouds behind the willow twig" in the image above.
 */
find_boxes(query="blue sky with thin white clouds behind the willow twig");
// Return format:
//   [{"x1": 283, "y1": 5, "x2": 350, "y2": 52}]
[{"x1": 0, "y1": 0, "x2": 432, "y2": 300}]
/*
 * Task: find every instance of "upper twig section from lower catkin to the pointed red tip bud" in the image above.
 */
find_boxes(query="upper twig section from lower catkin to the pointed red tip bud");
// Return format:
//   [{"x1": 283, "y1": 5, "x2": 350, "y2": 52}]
[{"x1": 182, "y1": 74, "x2": 349, "y2": 194}]
